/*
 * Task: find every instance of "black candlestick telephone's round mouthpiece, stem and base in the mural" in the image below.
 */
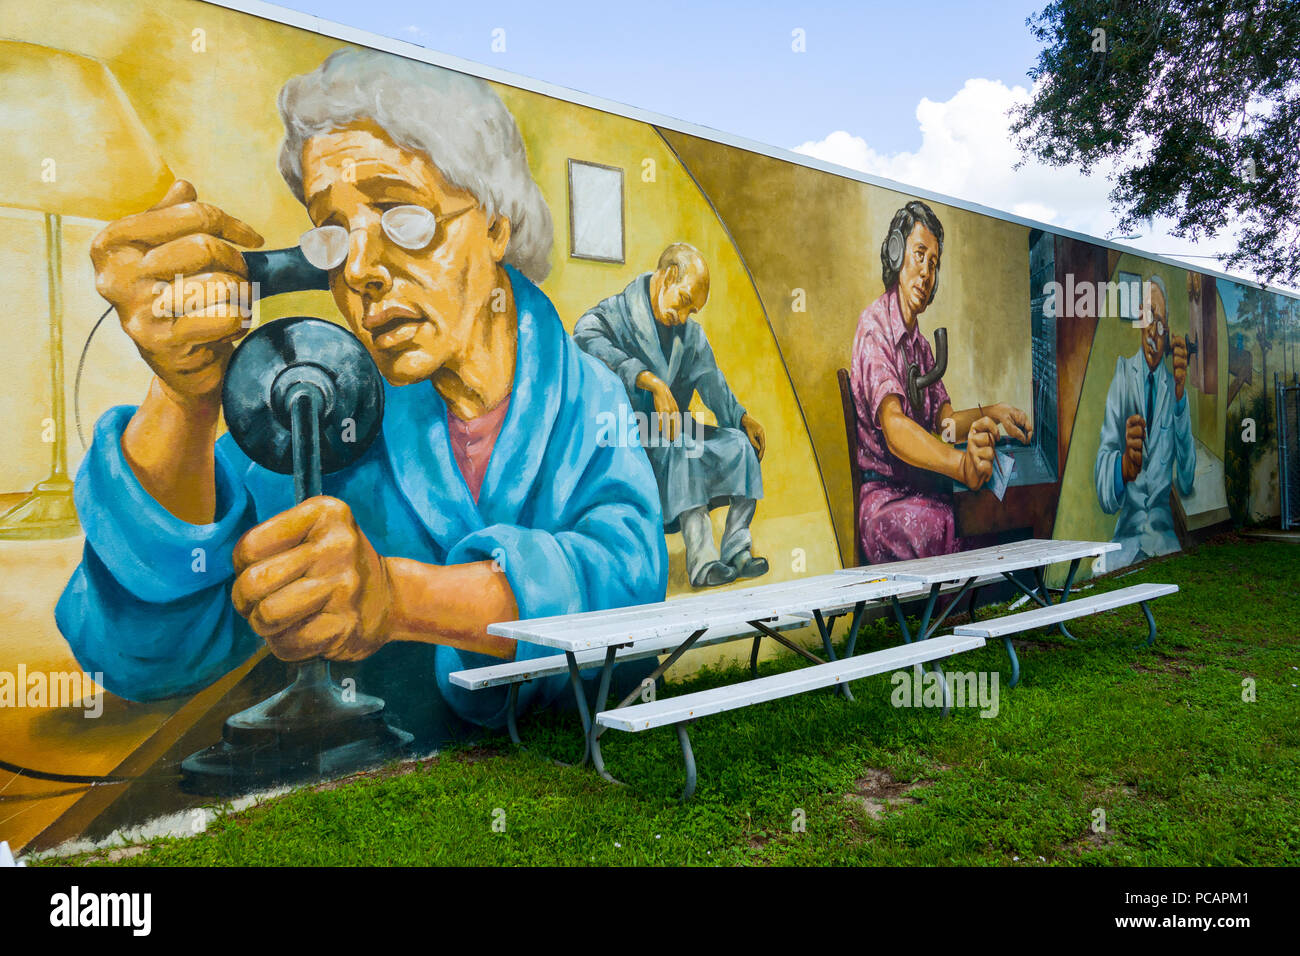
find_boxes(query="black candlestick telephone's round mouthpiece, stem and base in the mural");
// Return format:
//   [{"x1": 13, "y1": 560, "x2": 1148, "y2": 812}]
[{"x1": 181, "y1": 317, "x2": 412, "y2": 796}]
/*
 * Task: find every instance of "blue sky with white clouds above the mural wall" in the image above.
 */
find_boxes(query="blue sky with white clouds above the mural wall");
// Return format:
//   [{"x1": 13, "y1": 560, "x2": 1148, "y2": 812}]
[{"x1": 271, "y1": 0, "x2": 1289, "y2": 291}]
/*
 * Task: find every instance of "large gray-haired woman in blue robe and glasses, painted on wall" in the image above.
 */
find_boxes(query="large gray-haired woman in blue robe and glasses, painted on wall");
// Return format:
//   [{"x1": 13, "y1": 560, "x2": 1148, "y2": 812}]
[{"x1": 56, "y1": 49, "x2": 667, "y2": 736}]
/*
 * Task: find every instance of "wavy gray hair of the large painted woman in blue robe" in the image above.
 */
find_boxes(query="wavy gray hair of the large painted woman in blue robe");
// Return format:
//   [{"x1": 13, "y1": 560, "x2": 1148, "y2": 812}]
[{"x1": 280, "y1": 48, "x2": 554, "y2": 282}]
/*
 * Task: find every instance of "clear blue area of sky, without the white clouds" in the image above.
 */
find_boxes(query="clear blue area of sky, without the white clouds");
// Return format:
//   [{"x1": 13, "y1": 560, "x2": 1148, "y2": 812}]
[{"x1": 274, "y1": 0, "x2": 1041, "y2": 152}]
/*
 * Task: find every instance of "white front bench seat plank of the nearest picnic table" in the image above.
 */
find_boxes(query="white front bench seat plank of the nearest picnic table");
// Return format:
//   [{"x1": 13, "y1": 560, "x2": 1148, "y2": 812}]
[{"x1": 595, "y1": 635, "x2": 984, "y2": 732}]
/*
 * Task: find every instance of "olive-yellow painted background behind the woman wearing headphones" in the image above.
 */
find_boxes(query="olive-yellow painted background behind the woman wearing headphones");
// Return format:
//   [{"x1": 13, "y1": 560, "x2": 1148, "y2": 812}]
[{"x1": 664, "y1": 133, "x2": 1034, "y2": 564}]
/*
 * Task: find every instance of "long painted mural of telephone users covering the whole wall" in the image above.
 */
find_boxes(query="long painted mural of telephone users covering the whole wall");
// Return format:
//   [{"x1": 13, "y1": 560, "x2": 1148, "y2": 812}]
[{"x1": 0, "y1": 0, "x2": 1300, "y2": 848}]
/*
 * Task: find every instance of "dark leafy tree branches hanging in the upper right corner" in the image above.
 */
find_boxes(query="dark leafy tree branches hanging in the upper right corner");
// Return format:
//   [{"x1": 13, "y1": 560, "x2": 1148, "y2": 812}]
[{"x1": 1011, "y1": 0, "x2": 1300, "y2": 284}]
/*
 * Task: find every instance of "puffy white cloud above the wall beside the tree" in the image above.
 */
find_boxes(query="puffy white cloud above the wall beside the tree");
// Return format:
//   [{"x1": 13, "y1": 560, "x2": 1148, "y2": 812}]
[{"x1": 794, "y1": 79, "x2": 1279, "y2": 290}]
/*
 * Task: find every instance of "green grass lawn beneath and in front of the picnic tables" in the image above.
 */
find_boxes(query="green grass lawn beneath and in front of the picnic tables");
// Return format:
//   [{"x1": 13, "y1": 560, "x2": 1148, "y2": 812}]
[{"x1": 47, "y1": 537, "x2": 1300, "y2": 866}]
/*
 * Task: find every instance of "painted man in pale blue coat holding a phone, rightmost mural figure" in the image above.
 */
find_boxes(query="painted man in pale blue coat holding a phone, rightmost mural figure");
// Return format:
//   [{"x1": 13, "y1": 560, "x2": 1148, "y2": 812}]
[{"x1": 1093, "y1": 276, "x2": 1196, "y2": 567}]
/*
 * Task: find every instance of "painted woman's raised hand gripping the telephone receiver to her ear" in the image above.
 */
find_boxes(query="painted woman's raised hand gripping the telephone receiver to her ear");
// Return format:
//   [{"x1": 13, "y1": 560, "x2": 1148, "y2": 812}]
[{"x1": 91, "y1": 179, "x2": 263, "y2": 405}]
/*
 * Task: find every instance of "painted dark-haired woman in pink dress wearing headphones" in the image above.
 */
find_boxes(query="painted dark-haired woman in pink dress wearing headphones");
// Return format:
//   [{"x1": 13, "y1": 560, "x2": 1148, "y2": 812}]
[{"x1": 850, "y1": 200, "x2": 1034, "y2": 564}]
